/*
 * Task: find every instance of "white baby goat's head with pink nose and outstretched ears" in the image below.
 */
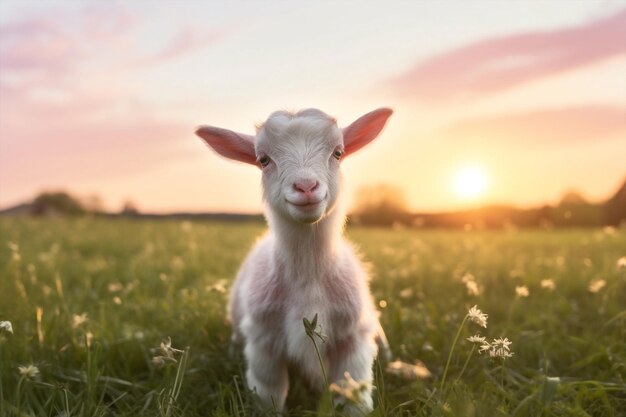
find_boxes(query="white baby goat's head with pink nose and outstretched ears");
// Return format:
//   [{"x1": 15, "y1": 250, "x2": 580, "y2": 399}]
[{"x1": 196, "y1": 108, "x2": 392, "y2": 223}]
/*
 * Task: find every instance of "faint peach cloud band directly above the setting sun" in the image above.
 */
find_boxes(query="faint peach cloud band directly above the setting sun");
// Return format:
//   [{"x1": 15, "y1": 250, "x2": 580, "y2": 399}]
[{"x1": 445, "y1": 106, "x2": 626, "y2": 147}]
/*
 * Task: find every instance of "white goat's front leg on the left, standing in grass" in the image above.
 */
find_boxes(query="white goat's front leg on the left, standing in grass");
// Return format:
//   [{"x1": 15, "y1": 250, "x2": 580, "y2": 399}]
[{"x1": 244, "y1": 343, "x2": 289, "y2": 411}]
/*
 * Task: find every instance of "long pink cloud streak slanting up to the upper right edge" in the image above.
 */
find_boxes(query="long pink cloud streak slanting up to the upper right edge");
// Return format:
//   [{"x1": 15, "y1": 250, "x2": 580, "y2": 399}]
[{"x1": 391, "y1": 9, "x2": 626, "y2": 101}]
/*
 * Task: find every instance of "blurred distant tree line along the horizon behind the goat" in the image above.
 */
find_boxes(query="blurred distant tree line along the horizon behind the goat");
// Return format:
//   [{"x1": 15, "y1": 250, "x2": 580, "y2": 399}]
[{"x1": 0, "y1": 181, "x2": 626, "y2": 229}]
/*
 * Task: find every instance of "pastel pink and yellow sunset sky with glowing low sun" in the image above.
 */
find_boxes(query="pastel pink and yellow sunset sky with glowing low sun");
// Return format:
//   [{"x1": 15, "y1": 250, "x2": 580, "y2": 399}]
[{"x1": 0, "y1": 0, "x2": 626, "y2": 212}]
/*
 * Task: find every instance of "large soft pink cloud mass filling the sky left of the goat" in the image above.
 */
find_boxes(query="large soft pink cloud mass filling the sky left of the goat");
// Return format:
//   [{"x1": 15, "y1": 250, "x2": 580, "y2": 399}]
[{"x1": 0, "y1": 6, "x2": 216, "y2": 202}]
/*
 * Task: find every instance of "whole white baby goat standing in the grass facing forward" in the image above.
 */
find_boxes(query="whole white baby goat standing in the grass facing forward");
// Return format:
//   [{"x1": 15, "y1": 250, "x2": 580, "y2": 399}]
[{"x1": 196, "y1": 108, "x2": 392, "y2": 415}]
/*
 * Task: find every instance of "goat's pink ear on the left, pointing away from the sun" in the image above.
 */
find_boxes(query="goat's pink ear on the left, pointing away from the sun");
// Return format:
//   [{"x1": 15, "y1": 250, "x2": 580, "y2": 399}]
[{"x1": 196, "y1": 126, "x2": 257, "y2": 165}]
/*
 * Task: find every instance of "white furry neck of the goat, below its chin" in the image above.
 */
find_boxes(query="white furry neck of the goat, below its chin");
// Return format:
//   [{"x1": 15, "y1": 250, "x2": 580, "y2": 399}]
[{"x1": 268, "y1": 204, "x2": 345, "y2": 281}]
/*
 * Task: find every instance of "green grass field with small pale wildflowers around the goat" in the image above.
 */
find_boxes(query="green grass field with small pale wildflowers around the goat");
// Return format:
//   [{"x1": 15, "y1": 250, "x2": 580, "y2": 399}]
[{"x1": 0, "y1": 218, "x2": 626, "y2": 417}]
